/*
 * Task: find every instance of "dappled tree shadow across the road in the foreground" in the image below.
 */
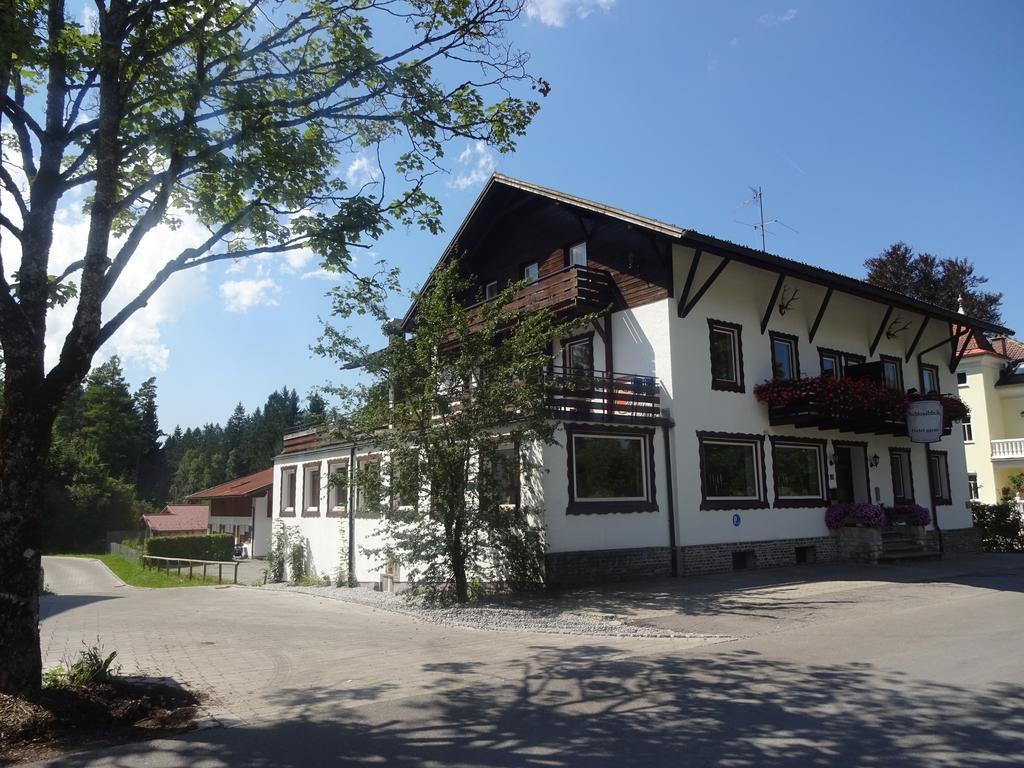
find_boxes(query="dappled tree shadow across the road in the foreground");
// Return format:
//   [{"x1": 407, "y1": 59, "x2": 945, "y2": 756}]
[{"x1": 48, "y1": 644, "x2": 1024, "y2": 768}]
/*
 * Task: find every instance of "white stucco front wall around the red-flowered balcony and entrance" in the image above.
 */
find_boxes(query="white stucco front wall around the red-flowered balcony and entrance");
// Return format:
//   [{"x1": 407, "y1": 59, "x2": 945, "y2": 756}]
[{"x1": 670, "y1": 247, "x2": 971, "y2": 545}]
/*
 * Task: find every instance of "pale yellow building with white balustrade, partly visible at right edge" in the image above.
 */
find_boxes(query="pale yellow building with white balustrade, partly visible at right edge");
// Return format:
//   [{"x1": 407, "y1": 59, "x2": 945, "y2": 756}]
[{"x1": 956, "y1": 337, "x2": 1024, "y2": 504}]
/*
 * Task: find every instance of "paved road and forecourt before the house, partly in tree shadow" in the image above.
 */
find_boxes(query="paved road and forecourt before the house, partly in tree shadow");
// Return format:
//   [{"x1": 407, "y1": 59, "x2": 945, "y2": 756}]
[{"x1": 32, "y1": 556, "x2": 1024, "y2": 768}]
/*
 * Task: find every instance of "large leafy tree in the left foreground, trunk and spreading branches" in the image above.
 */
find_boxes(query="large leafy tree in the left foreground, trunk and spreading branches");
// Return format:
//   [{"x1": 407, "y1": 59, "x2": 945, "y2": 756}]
[{"x1": 0, "y1": 0, "x2": 547, "y2": 694}]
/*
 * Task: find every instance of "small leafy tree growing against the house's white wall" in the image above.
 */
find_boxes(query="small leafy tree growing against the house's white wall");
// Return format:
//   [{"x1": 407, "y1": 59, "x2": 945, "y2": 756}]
[{"x1": 322, "y1": 262, "x2": 586, "y2": 602}]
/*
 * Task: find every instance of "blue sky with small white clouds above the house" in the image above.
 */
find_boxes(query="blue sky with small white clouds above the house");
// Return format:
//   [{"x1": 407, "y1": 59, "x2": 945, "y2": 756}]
[{"x1": 86, "y1": 0, "x2": 1024, "y2": 429}]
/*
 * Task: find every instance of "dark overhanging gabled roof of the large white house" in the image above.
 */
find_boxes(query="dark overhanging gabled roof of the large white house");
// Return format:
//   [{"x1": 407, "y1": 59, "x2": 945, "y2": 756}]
[{"x1": 401, "y1": 178, "x2": 1012, "y2": 335}]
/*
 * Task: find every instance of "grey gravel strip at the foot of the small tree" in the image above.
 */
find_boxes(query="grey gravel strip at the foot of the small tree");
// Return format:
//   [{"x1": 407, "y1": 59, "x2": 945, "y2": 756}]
[{"x1": 262, "y1": 584, "x2": 731, "y2": 640}]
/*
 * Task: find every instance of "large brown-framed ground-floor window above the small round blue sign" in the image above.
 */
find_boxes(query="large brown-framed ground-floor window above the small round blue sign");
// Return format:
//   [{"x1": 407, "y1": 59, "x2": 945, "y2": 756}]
[{"x1": 697, "y1": 432, "x2": 768, "y2": 509}]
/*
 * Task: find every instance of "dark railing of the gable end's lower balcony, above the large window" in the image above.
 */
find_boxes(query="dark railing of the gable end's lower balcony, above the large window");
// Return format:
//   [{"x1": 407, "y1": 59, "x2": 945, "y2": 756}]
[{"x1": 548, "y1": 367, "x2": 662, "y2": 424}]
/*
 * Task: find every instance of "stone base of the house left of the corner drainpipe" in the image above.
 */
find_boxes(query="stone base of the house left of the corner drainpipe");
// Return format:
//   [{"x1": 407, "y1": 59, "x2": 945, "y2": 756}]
[{"x1": 544, "y1": 547, "x2": 672, "y2": 587}]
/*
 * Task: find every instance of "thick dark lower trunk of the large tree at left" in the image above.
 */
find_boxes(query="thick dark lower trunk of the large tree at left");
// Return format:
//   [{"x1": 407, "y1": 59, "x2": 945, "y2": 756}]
[{"x1": 0, "y1": 370, "x2": 55, "y2": 697}]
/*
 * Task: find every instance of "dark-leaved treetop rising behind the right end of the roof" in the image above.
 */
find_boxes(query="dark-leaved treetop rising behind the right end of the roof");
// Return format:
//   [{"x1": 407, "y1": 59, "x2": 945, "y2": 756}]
[{"x1": 864, "y1": 242, "x2": 1002, "y2": 324}]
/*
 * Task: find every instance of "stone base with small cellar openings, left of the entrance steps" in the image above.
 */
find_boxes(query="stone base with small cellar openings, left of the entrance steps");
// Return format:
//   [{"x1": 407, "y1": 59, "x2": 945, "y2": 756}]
[{"x1": 679, "y1": 536, "x2": 839, "y2": 575}]
